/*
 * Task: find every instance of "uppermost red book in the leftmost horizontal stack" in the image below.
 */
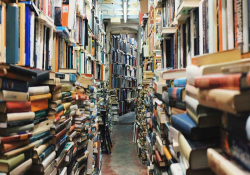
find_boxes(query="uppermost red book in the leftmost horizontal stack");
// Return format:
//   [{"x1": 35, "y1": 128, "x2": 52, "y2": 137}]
[{"x1": 0, "y1": 101, "x2": 31, "y2": 113}]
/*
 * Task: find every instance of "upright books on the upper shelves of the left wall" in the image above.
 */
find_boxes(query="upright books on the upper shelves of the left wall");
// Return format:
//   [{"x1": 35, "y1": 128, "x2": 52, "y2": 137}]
[{"x1": 0, "y1": 0, "x2": 107, "y2": 76}]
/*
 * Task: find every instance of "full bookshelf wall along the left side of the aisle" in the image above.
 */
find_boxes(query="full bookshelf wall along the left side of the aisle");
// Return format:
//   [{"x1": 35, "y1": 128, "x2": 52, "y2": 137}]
[{"x1": 0, "y1": 0, "x2": 109, "y2": 175}]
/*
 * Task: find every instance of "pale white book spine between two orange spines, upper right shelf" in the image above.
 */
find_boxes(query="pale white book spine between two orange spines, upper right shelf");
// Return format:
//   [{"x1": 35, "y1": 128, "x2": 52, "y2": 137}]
[{"x1": 227, "y1": 0, "x2": 234, "y2": 50}]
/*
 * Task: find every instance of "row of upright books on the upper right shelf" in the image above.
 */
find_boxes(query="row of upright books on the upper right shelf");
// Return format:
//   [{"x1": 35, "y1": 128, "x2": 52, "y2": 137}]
[{"x1": 162, "y1": 0, "x2": 250, "y2": 69}]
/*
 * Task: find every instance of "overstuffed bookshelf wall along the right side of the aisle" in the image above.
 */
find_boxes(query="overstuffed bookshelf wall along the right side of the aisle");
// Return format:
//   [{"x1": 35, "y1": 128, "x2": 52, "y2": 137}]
[{"x1": 137, "y1": 0, "x2": 250, "y2": 174}]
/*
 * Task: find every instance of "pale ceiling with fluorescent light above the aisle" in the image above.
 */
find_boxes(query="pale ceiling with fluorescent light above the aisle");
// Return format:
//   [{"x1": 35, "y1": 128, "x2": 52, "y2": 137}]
[{"x1": 98, "y1": 0, "x2": 140, "y2": 21}]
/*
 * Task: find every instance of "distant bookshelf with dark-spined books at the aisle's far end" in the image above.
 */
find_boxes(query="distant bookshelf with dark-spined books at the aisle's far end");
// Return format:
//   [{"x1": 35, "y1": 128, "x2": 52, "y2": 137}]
[{"x1": 110, "y1": 34, "x2": 137, "y2": 115}]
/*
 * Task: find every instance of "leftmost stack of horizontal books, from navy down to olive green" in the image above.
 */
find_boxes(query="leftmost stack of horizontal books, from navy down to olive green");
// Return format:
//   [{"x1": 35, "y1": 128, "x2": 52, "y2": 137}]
[{"x1": 0, "y1": 75, "x2": 35, "y2": 174}]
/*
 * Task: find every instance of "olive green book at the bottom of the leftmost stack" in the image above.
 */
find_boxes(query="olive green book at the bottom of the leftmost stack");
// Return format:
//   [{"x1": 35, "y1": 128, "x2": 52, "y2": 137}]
[{"x1": 0, "y1": 154, "x2": 25, "y2": 173}]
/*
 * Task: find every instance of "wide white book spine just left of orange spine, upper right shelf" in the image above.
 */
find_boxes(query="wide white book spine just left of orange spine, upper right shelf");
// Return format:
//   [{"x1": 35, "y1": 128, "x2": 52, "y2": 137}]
[{"x1": 208, "y1": 0, "x2": 217, "y2": 53}]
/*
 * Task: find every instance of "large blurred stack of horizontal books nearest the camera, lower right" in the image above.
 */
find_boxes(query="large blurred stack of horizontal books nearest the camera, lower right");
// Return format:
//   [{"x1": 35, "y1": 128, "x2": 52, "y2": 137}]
[{"x1": 186, "y1": 50, "x2": 250, "y2": 174}]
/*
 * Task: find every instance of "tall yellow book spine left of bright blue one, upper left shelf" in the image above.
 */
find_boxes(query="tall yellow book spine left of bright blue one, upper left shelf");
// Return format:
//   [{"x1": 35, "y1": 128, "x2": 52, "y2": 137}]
[{"x1": 17, "y1": 3, "x2": 25, "y2": 66}]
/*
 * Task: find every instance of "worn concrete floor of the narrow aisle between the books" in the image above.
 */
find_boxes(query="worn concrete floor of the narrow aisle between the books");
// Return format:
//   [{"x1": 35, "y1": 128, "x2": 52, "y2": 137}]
[{"x1": 102, "y1": 112, "x2": 147, "y2": 175}]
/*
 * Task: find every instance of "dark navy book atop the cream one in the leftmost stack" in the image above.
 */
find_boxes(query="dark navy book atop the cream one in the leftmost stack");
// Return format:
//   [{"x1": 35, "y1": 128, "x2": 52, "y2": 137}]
[{"x1": 0, "y1": 78, "x2": 29, "y2": 92}]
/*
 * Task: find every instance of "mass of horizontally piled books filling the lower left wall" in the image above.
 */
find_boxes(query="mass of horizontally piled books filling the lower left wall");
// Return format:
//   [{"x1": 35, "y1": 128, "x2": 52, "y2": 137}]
[{"x1": 0, "y1": 64, "x2": 102, "y2": 174}]
